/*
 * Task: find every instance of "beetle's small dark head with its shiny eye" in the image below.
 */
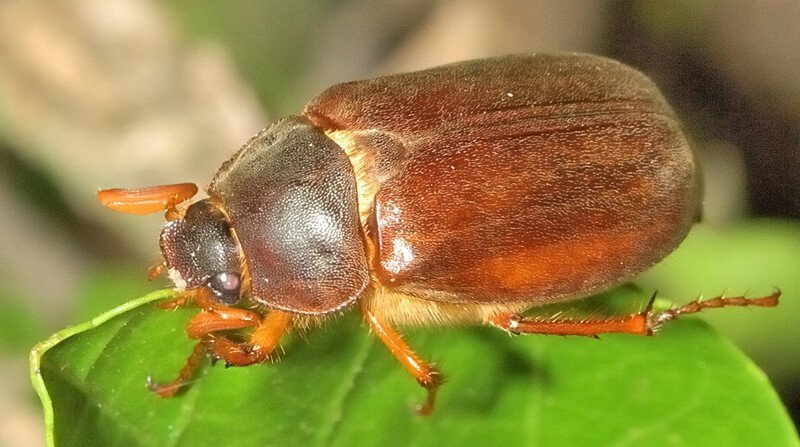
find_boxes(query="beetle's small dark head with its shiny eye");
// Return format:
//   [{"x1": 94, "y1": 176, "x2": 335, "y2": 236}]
[{"x1": 160, "y1": 200, "x2": 242, "y2": 305}]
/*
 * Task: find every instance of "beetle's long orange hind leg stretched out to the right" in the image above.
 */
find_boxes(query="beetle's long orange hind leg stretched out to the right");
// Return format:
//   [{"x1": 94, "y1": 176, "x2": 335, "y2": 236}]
[{"x1": 490, "y1": 291, "x2": 781, "y2": 337}]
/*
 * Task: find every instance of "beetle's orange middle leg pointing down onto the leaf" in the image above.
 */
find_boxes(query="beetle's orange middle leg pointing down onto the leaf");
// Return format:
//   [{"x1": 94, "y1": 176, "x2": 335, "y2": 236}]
[{"x1": 363, "y1": 309, "x2": 442, "y2": 414}]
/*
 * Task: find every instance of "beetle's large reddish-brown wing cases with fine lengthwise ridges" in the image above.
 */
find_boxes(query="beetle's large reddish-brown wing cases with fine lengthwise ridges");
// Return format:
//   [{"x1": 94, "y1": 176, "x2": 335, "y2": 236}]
[{"x1": 305, "y1": 51, "x2": 697, "y2": 303}]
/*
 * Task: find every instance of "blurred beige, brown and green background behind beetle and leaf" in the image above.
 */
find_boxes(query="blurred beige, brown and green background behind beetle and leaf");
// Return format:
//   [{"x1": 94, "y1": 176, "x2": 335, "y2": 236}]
[{"x1": 0, "y1": 0, "x2": 800, "y2": 446}]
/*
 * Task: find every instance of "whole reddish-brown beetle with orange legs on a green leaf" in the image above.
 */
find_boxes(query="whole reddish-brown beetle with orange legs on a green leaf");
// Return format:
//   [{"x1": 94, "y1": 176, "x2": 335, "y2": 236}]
[{"x1": 98, "y1": 54, "x2": 779, "y2": 413}]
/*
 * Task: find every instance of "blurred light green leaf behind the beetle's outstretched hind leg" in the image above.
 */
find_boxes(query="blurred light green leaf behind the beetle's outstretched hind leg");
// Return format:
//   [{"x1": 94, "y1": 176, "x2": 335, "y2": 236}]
[{"x1": 637, "y1": 219, "x2": 800, "y2": 382}]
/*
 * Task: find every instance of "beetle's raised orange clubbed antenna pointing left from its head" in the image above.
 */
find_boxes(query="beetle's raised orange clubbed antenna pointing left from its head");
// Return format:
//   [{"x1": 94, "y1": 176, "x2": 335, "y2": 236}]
[{"x1": 97, "y1": 183, "x2": 197, "y2": 219}]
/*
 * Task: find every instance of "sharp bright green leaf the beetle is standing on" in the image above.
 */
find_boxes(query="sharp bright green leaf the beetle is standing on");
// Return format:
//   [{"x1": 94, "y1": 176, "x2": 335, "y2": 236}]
[{"x1": 31, "y1": 290, "x2": 800, "y2": 446}]
